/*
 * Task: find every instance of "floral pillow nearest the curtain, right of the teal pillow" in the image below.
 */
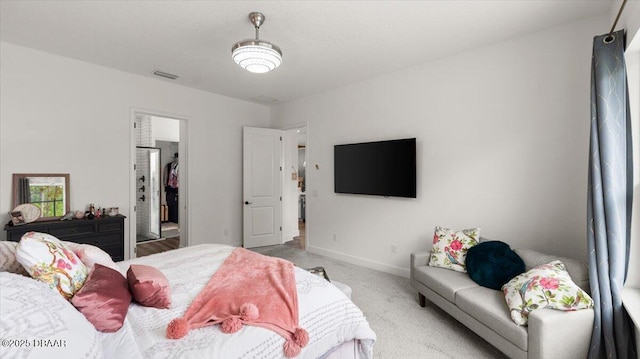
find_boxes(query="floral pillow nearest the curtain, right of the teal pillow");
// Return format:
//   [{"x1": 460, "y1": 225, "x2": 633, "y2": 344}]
[{"x1": 502, "y1": 261, "x2": 593, "y2": 325}]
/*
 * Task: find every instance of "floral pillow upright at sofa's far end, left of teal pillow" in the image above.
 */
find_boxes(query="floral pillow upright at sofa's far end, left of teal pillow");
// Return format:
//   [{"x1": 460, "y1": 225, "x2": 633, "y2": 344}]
[{"x1": 429, "y1": 226, "x2": 480, "y2": 273}]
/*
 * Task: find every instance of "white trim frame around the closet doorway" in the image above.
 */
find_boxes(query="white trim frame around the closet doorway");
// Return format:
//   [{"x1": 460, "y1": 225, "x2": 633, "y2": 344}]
[{"x1": 129, "y1": 107, "x2": 191, "y2": 260}]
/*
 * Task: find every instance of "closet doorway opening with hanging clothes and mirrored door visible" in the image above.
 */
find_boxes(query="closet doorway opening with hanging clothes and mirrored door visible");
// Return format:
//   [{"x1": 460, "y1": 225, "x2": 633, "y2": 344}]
[{"x1": 130, "y1": 112, "x2": 188, "y2": 257}]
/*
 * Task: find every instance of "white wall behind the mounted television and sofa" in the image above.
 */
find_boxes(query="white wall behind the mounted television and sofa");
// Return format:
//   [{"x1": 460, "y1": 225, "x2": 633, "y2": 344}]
[{"x1": 271, "y1": 16, "x2": 608, "y2": 276}]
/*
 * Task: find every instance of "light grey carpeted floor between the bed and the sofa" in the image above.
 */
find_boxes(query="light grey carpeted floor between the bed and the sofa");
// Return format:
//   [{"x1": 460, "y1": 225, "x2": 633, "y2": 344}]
[{"x1": 252, "y1": 245, "x2": 506, "y2": 359}]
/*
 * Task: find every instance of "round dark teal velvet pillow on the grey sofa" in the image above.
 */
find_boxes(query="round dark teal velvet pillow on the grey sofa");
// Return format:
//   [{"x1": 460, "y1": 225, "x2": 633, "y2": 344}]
[{"x1": 466, "y1": 241, "x2": 525, "y2": 290}]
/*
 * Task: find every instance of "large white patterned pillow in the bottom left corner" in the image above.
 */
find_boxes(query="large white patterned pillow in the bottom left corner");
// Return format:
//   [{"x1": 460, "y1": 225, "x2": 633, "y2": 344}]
[{"x1": 0, "y1": 272, "x2": 103, "y2": 358}]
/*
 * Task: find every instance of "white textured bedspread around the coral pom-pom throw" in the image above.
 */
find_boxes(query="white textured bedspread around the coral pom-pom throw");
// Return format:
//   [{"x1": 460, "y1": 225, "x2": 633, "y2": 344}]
[{"x1": 99, "y1": 244, "x2": 376, "y2": 359}]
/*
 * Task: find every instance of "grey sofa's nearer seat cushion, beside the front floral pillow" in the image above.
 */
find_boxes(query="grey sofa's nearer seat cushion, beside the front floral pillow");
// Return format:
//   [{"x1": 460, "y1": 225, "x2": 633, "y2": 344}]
[{"x1": 455, "y1": 286, "x2": 528, "y2": 351}]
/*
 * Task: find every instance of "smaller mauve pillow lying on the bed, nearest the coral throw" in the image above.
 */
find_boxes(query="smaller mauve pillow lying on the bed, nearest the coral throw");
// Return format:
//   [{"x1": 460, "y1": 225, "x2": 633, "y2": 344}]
[{"x1": 127, "y1": 264, "x2": 171, "y2": 309}]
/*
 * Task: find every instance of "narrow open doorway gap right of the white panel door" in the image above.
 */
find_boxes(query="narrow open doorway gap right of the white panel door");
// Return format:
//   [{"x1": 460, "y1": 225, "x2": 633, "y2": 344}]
[{"x1": 284, "y1": 126, "x2": 307, "y2": 250}]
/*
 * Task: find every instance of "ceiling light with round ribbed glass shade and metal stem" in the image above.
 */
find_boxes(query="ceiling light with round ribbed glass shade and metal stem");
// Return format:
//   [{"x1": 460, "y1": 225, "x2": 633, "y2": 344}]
[{"x1": 231, "y1": 12, "x2": 282, "y2": 74}]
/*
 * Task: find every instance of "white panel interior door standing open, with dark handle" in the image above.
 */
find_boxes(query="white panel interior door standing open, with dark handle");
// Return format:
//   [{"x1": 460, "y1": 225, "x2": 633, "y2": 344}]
[{"x1": 242, "y1": 127, "x2": 282, "y2": 248}]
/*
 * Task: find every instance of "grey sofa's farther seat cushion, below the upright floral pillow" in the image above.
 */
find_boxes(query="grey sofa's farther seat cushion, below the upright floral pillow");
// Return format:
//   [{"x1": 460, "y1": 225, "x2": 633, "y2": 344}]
[{"x1": 414, "y1": 266, "x2": 478, "y2": 303}]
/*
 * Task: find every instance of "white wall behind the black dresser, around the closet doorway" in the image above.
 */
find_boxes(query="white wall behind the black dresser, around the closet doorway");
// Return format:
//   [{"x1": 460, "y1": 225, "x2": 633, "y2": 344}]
[{"x1": 0, "y1": 43, "x2": 269, "y2": 252}]
